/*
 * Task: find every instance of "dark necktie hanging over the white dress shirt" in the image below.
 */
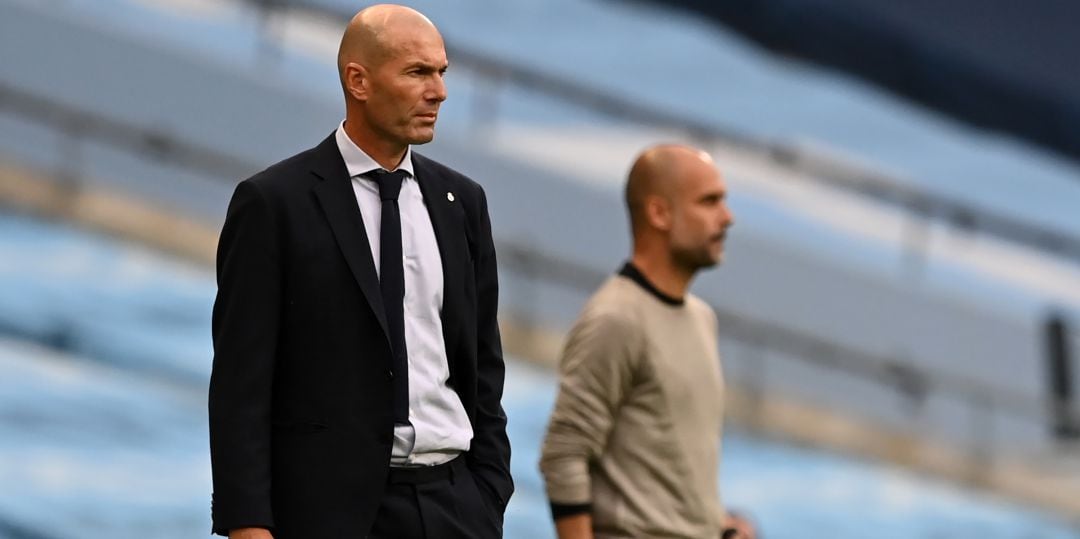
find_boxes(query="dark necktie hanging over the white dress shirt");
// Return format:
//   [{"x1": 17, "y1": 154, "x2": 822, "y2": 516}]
[{"x1": 367, "y1": 170, "x2": 408, "y2": 425}]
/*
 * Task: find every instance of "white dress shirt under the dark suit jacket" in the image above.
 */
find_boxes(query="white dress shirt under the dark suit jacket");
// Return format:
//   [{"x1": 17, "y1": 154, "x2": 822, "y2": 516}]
[{"x1": 336, "y1": 122, "x2": 473, "y2": 466}]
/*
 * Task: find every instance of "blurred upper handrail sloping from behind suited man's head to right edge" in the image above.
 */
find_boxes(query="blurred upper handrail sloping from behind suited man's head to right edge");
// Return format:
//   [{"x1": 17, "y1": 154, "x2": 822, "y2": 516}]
[{"x1": 259, "y1": 0, "x2": 1080, "y2": 262}]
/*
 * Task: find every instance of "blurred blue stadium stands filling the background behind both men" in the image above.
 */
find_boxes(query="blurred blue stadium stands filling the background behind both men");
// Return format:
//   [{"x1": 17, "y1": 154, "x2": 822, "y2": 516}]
[{"x1": 0, "y1": 0, "x2": 1080, "y2": 539}]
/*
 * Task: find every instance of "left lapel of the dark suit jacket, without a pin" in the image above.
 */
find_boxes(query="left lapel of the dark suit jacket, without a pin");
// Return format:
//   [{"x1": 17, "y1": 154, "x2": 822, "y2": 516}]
[{"x1": 311, "y1": 134, "x2": 390, "y2": 335}]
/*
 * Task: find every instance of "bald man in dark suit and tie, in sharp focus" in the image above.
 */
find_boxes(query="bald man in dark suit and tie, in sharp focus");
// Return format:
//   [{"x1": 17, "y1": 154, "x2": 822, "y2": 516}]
[{"x1": 210, "y1": 5, "x2": 513, "y2": 539}]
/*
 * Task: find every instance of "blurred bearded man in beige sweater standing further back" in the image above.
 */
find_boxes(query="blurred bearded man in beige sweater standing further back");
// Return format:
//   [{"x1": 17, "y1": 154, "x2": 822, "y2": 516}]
[{"x1": 540, "y1": 145, "x2": 752, "y2": 539}]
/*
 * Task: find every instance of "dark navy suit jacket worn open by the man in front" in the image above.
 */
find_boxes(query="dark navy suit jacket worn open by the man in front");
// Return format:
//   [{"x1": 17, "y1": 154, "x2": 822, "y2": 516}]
[{"x1": 208, "y1": 135, "x2": 513, "y2": 539}]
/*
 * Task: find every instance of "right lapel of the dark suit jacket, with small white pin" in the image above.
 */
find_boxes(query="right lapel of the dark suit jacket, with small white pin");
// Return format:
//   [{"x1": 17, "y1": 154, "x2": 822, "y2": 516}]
[{"x1": 413, "y1": 151, "x2": 469, "y2": 362}]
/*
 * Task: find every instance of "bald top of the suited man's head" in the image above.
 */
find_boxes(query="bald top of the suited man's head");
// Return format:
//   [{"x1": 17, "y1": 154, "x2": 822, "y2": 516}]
[{"x1": 338, "y1": 3, "x2": 442, "y2": 93}]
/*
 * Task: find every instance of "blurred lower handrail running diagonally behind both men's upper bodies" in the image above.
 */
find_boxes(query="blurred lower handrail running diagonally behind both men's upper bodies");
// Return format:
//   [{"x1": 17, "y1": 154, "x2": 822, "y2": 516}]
[{"x1": 0, "y1": 32, "x2": 1080, "y2": 438}]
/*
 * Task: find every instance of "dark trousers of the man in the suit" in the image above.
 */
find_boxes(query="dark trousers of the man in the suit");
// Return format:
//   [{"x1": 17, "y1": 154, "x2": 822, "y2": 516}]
[{"x1": 368, "y1": 457, "x2": 502, "y2": 539}]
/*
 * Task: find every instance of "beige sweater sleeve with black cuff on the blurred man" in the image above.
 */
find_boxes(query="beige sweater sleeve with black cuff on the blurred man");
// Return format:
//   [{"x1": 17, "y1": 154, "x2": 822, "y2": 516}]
[{"x1": 540, "y1": 312, "x2": 640, "y2": 506}]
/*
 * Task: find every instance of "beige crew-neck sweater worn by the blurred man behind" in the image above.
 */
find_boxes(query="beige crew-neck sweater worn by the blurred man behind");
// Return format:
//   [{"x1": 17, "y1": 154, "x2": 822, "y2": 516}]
[{"x1": 540, "y1": 275, "x2": 725, "y2": 538}]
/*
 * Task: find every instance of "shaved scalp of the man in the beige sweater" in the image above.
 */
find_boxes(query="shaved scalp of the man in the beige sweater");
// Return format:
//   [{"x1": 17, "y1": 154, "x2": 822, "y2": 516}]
[{"x1": 626, "y1": 144, "x2": 716, "y2": 234}]
